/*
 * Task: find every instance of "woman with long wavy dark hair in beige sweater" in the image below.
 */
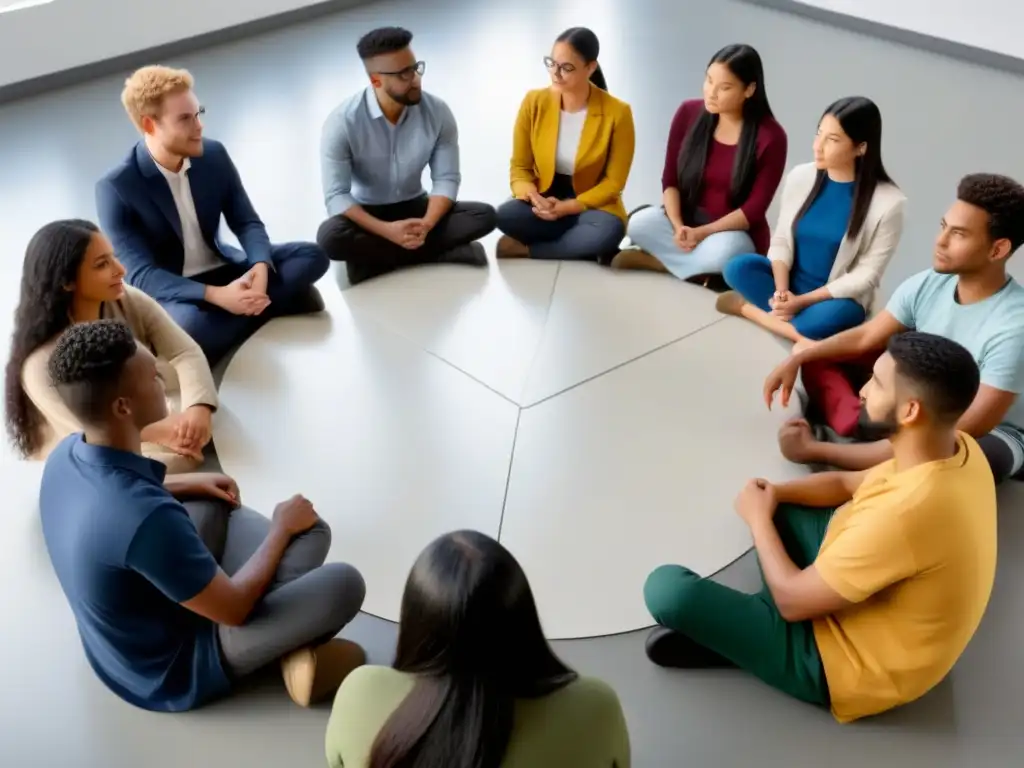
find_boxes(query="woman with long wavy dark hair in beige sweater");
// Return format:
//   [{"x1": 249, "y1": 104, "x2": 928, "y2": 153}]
[{"x1": 5, "y1": 220, "x2": 217, "y2": 473}]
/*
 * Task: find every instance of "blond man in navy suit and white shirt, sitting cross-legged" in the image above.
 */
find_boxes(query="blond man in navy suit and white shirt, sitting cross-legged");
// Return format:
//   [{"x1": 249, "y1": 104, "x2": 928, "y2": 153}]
[{"x1": 95, "y1": 66, "x2": 329, "y2": 366}]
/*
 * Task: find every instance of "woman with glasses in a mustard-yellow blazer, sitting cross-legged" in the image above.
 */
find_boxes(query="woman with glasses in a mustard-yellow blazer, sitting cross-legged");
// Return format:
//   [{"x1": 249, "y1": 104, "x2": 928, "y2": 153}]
[{"x1": 498, "y1": 27, "x2": 635, "y2": 263}]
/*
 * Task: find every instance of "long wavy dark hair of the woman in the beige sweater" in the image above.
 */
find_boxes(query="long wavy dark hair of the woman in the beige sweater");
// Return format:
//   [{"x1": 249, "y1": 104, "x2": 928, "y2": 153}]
[{"x1": 4, "y1": 219, "x2": 99, "y2": 457}]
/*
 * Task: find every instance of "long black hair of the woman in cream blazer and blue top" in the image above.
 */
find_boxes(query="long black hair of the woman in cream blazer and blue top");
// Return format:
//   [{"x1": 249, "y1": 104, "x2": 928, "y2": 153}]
[{"x1": 793, "y1": 96, "x2": 896, "y2": 243}]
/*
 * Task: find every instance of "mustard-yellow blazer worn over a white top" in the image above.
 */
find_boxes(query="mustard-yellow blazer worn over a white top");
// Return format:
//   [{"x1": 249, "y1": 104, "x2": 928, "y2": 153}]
[{"x1": 511, "y1": 85, "x2": 636, "y2": 221}]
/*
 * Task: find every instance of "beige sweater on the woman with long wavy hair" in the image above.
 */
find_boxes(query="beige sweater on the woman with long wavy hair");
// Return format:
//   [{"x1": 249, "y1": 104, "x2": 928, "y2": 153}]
[{"x1": 22, "y1": 286, "x2": 217, "y2": 474}]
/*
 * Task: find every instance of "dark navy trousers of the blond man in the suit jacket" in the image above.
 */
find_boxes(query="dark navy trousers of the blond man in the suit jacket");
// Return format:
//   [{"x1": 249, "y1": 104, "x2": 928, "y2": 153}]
[{"x1": 163, "y1": 243, "x2": 331, "y2": 366}]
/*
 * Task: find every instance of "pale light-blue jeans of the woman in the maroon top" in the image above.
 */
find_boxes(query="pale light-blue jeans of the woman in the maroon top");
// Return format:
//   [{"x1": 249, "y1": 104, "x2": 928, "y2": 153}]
[{"x1": 626, "y1": 206, "x2": 754, "y2": 280}]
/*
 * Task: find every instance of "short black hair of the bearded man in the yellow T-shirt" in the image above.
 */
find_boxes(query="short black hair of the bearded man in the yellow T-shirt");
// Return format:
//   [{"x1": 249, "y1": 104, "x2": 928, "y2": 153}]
[{"x1": 887, "y1": 331, "x2": 981, "y2": 425}]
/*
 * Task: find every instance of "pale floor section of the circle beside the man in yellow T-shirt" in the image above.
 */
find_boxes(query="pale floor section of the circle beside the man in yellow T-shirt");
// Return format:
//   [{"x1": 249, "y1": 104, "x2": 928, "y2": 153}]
[{"x1": 502, "y1": 319, "x2": 804, "y2": 638}]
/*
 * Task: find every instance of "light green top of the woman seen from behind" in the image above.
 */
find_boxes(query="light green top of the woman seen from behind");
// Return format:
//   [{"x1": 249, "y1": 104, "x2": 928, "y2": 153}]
[{"x1": 327, "y1": 667, "x2": 630, "y2": 768}]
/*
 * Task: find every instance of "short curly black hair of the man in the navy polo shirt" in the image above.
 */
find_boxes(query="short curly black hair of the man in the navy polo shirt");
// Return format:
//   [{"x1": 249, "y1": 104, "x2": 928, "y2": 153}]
[{"x1": 48, "y1": 319, "x2": 138, "y2": 425}]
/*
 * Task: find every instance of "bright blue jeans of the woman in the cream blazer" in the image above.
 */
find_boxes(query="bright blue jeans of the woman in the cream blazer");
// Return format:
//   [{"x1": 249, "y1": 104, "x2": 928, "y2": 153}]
[{"x1": 723, "y1": 253, "x2": 866, "y2": 341}]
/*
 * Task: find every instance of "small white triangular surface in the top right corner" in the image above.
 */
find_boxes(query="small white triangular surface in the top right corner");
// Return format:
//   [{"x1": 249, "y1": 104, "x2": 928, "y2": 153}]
[{"x1": 798, "y1": 0, "x2": 1024, "y2": 58}]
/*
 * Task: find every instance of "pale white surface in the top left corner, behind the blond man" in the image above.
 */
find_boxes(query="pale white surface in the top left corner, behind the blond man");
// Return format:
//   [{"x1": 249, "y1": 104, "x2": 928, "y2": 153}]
[{"x1": 0, "y1": 0, "x2": 342, "y2": 88}]
